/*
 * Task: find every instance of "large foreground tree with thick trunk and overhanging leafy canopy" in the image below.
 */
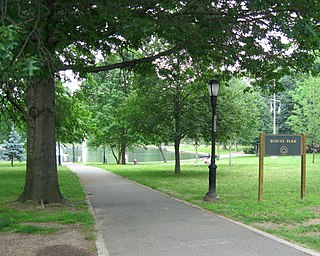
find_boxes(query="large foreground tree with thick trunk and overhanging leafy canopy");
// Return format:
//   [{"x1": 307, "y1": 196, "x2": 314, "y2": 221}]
[{"x1": 0, "y1": 0, "x2": 320, "y2": 203}]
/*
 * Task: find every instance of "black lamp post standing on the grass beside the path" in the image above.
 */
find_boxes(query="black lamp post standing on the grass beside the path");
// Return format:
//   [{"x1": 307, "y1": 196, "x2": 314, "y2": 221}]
[{"x1": 203, "y1": 79, "x2": 219, "y2": 202}]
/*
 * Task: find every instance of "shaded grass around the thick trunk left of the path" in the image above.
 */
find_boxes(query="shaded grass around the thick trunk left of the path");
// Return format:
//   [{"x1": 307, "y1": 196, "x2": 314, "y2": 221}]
[{"x1": 0, "y1": 162, "x2": 93, "y2": 236}]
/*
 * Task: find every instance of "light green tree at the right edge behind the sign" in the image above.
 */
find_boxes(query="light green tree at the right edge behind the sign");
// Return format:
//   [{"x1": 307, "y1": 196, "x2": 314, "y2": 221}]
[{"x1": 288, "y1": 76, "x2": 320, "y2": 163}]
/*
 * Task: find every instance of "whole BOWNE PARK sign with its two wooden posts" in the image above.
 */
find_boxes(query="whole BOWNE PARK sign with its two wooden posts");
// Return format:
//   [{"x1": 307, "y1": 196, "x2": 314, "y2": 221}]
[{"x1": 258, "y1": 133, "x2": 306, "y2": 202}]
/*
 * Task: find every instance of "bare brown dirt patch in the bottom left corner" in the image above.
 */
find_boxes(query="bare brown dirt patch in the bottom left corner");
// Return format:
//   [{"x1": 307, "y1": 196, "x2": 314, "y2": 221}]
[{"x1": 0, "y1": 223, "x2": 98, "y2": 256}]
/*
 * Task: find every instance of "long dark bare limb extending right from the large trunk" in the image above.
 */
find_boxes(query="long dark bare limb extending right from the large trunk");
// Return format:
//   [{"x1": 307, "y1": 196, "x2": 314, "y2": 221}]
[{"x1": 58, "y1": 46, "x2": 181, "y2": 73}]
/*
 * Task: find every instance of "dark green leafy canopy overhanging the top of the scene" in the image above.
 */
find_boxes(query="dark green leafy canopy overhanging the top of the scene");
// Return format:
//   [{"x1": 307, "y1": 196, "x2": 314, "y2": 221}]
[{"x1": 0, "y1": 0, "x2": 320, "y2": 81}]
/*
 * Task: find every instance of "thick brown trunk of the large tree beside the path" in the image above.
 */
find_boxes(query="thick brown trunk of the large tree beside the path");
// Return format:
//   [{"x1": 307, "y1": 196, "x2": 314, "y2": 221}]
[{"x1": 18, "y1": 78, "x2": 64, "y2": 204}]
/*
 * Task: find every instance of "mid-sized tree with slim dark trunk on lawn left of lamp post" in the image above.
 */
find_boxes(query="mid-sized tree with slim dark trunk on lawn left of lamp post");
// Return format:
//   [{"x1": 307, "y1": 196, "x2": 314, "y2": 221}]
[{"x1": 127, "y1": 55, "x2": 211, "y2": 174}]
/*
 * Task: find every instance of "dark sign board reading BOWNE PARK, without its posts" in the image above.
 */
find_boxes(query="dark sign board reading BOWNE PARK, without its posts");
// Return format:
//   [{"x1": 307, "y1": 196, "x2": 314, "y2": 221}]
[{"x1": 264, "y1": 134, "x2": 302, "y2": 156}]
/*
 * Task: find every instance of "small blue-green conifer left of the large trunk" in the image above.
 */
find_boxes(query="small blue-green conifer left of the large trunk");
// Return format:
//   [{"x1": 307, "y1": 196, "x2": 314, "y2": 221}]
[{"x1": 4, "y1": 128, "x2": 24, "y2": 166}]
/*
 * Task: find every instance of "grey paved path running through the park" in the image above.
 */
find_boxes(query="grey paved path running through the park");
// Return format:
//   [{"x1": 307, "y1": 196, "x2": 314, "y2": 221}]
[{"x1": 69, "y1": 164, "x2": 320, "y2": 256}]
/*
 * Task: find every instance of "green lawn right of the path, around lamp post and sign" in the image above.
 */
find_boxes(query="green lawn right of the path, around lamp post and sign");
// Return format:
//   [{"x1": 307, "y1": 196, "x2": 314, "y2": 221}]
[{"x1": 91, "y1": 156, "x2": 320, "y2": 251}]
